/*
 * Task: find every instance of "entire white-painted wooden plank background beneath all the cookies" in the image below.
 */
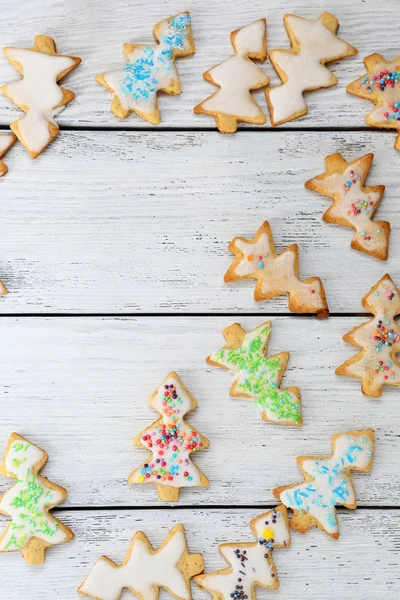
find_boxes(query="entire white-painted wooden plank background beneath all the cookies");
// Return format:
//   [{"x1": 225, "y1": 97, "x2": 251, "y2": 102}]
[{"x1": 0, "y1": 0, "x2": 400, "y2": 600}]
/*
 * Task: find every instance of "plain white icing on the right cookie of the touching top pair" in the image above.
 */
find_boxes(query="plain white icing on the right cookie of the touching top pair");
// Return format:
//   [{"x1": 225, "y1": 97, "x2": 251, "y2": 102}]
[{"x1": 268, "y1": 15, "x2": 349, "y2": 124}]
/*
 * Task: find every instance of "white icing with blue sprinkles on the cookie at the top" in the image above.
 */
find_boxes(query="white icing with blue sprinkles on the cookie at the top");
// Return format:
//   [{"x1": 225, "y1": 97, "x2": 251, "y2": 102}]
[{"x1": 103, "y1": 13, "x2": 191, "y2": 115}]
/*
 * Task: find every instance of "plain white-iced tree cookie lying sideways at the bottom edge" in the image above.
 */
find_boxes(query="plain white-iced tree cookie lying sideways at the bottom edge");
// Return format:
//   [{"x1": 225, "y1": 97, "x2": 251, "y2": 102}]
[{"x1": 78, "y1": 524, "x2": 204, "y2": 600}]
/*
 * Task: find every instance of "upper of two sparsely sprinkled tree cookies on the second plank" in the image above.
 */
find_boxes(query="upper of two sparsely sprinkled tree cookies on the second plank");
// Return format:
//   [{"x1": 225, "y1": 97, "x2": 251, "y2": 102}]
[{"x1": 305, "y1": 153, "x2": 390, "y2": 260}]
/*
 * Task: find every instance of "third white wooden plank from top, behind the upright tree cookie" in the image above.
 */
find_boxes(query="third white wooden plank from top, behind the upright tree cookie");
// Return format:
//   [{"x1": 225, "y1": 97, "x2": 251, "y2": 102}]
[{"x1": 0, "y1": 317, "x2": 400, "y2": 508}]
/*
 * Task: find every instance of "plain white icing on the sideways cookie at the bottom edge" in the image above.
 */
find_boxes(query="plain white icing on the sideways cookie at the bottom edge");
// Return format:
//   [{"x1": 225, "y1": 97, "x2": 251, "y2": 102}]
[{"x1": 79, "y1": 530, "x2": 190, "y2": 600}]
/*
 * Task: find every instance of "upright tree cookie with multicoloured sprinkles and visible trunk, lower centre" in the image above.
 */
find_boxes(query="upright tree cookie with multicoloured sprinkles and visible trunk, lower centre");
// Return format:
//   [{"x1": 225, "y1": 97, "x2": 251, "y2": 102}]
[{"x1": 129, "y1": 372, "x2": 210, "y2": 502}]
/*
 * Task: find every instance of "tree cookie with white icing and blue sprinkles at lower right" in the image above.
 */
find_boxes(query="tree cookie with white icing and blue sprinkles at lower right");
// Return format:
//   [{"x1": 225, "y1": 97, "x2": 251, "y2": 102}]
[{"x1": 274, "y1": 429, "x2": 375, "y2": 540}]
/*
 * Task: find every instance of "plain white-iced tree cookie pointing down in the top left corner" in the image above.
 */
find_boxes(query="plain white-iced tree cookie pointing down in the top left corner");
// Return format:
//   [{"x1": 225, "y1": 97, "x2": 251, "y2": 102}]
[{"x1": 1, "y1": 35, "x2": 81, "y2": 158}]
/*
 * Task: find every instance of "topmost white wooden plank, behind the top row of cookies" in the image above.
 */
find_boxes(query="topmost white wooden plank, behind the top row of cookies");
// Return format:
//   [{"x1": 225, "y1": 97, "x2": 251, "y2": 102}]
[{"x1": 0, "y1": 0, "x2": 398, "y2": 129}]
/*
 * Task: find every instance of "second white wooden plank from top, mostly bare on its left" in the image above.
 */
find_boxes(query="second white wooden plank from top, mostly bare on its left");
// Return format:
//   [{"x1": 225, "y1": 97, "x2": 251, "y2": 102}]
[{"x1": 0, "y1": 132, "x2": 400, "y2": 313}]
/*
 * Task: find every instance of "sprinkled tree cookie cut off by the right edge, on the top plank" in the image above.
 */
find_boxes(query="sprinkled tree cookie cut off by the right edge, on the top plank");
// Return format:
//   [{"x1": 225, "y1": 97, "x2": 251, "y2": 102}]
[{"x1": 346, "y1": 53, "x2": 400, "y2": 150}]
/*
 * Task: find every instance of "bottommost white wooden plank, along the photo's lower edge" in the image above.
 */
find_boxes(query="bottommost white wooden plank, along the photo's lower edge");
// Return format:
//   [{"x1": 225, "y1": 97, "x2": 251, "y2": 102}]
[{"x1": 0, "y1": 509, "x2": 400, "y2": 600}]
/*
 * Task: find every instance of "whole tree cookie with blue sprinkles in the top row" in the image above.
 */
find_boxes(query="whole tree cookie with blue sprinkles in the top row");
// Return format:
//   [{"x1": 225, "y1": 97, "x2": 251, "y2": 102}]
[{"x1": 95, "y1": 12, "x2": 194, "y2": 125}]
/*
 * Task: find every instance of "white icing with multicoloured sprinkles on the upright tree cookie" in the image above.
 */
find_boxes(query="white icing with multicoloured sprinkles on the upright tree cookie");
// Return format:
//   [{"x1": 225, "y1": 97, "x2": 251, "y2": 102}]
[{"x1": 129, "y1": 376, "x2": 202, "y2": 487}]
